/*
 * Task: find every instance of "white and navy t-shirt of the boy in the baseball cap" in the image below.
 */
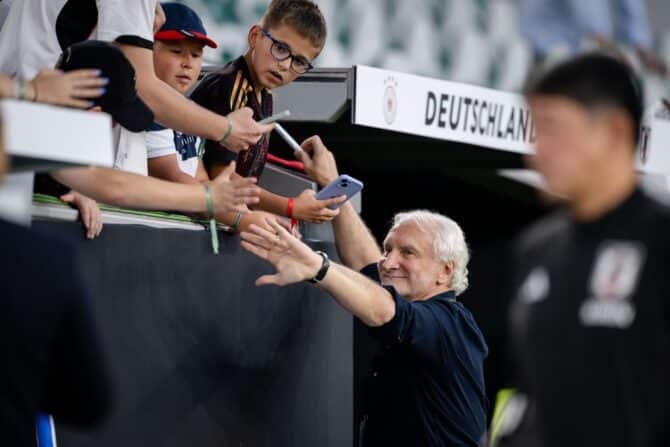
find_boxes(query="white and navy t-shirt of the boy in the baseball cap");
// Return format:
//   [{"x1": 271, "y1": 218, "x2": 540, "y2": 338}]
[{"x1": 146, "y1": 125, "x2": 200, "y2": 177}]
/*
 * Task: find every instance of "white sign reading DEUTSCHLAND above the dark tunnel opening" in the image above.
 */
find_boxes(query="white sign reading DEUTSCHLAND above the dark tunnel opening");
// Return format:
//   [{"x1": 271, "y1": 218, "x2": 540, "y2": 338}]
[{"x1": 354, "y1": 65, "x2": 534, "y2": 153}]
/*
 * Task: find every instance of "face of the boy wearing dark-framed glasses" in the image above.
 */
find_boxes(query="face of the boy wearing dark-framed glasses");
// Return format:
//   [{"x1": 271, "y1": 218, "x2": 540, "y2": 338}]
[{"x1": 249, "y1": 25, "x2": 320, "y2": 89}]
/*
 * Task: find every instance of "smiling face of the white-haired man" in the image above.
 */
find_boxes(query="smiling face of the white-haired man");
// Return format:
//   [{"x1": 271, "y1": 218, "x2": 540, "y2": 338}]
[{"x1": 379, "y1": 223, "x2": 453, "y2": 300}]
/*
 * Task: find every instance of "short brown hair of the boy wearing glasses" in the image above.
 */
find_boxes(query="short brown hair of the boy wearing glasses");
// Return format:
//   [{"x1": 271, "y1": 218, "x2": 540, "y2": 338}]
[{"x1": 261, "y1": 0, "x2": 327, "y2": 48}]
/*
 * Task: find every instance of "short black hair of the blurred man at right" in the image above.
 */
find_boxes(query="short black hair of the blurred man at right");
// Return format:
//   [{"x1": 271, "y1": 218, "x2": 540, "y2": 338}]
[{"x1": 524, "y1": 53, "x2": 643, "y2": 142}]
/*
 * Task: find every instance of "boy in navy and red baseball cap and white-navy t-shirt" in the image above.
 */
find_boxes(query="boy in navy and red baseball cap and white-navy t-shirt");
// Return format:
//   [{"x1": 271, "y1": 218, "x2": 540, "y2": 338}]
[{"x1": 146, "y1": 3, "x2": 217, "y2": 183}]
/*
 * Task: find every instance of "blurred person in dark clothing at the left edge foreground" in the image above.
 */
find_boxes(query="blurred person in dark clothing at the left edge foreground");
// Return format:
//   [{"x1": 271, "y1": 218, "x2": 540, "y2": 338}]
[{"x1": 0, "y1": 121, "x2": 110, "y2": 447}]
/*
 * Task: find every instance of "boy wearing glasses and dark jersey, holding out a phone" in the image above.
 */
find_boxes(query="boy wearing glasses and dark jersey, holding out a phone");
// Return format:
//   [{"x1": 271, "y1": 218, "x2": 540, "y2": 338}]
[{"x1": 191, "y1": 0, "x2": 339, "y2": 230}]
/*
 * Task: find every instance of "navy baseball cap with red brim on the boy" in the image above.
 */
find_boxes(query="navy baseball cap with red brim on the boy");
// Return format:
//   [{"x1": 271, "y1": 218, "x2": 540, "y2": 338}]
[{"x1": 154, "y1": 2, "x2": 218, "y2": 48}]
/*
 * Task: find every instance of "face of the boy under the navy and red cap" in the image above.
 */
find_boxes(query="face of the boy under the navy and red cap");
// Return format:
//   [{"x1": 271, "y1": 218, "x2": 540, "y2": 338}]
[{"x1": 154, "y1": 39, "x2": 204, "y2": 93}]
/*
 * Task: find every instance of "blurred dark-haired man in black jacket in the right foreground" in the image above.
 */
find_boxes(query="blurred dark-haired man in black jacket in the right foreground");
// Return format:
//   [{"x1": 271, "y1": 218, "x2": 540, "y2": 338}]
[{"x1": 498, "y1": 53, "x2": 670, "y2": 447}]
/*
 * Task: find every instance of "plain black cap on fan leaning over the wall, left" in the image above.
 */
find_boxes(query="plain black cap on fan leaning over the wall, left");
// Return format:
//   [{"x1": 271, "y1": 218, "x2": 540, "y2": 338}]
[{"x1": 56, "y1": 40, "x2": 154, "y2": 132}]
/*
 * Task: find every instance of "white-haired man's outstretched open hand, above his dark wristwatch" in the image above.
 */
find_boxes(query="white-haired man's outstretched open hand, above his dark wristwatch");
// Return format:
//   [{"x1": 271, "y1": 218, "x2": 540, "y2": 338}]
[{"x1": 240, "y1": 220, "x2": 322, "y2": 286}]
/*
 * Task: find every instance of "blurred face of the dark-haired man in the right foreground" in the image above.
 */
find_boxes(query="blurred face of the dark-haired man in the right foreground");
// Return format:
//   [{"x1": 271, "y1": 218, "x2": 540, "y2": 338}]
[{"x1": 527, "y1": 95, "x2": 608, "y2": 201}]
